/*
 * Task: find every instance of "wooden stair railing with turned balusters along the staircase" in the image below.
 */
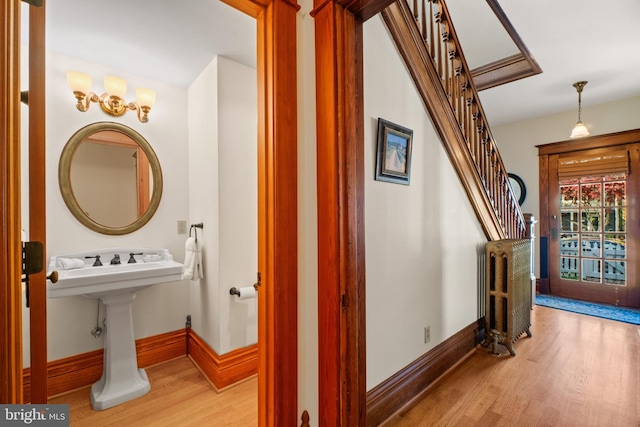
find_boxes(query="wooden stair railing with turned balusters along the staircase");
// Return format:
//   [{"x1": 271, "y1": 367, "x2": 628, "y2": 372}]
[{"x1": 407, "y1": 0, "x2": 525, "y2": 238}]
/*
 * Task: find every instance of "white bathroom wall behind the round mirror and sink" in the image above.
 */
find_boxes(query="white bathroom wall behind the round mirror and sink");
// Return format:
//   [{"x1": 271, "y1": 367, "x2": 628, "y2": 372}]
[{"x1": 36, "y1": 52, "x2": 189, "y2": 366}]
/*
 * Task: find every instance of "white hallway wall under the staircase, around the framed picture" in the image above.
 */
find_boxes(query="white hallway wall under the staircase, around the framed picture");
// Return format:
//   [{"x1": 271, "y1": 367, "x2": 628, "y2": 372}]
[{"x1": 364, "y1": 16, "x2": 487, "y2": 389}]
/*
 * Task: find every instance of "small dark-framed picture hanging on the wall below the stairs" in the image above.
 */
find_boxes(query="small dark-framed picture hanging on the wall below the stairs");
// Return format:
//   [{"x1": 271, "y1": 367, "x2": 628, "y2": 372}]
[{"x1": 376, "y1": 118, "x2": 413, "y2": 185}]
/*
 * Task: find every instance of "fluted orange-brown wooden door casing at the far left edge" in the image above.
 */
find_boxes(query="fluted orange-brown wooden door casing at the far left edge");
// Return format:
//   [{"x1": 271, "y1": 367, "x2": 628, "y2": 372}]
[{"x1": 0, "y1": 0, "x2": 22, "y2": 403}]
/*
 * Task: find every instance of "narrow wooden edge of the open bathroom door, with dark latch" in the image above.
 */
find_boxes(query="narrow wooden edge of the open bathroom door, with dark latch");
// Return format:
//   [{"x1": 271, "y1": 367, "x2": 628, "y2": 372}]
[{"x1": 29, "y1": 0, "x2": 48, "y2": 403}]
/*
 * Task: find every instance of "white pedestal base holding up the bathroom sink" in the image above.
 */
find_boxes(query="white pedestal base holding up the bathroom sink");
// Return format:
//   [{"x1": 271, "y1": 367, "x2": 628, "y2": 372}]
[{"x1": 91, "y1": 293, "x2": 151, "y2": 410}]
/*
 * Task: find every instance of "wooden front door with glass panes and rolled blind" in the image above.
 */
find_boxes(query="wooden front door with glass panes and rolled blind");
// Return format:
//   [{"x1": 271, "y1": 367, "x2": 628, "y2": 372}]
[{"x1": 548, "y1": 144, "x2": 640, "y2": 306}]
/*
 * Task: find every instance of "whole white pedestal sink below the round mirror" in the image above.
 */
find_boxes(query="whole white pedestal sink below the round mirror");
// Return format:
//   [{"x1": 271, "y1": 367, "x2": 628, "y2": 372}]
[{"x1": 47, "y1": 248, "x2": 182, "y2": 410}]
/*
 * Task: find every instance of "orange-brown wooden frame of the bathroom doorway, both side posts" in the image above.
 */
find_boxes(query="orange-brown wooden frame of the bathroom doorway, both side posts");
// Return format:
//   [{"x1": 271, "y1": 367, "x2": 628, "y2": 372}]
[{"x1": 0, "y1": 0, "x2": 299, "y2": 426}]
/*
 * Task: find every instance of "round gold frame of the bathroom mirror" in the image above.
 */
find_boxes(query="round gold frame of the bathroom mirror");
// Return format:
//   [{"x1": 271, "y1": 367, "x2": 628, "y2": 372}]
[{"x1": 58, "y1": 122, "x2": 162, "y2": 235}]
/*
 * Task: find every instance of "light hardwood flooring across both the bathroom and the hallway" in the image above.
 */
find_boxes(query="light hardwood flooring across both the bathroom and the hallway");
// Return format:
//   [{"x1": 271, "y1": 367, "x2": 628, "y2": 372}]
[{"x1": 50, "y1": 307, "x2": 640, "y2": 427}]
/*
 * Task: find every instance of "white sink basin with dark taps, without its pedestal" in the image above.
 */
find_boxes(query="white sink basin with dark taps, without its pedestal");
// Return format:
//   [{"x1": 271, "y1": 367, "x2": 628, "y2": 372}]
[{"x1": 47, "y1": 248, "x2": 182, "y2": 298}]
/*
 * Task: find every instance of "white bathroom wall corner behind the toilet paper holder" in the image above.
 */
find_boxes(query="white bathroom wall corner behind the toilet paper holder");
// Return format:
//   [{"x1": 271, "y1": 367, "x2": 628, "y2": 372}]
[{"x1": 189, "y1": 57, "x2": 258, "y2": 354}]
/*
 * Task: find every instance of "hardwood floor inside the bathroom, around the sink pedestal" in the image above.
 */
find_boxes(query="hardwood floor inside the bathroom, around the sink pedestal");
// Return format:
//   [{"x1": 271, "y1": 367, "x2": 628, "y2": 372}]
[{"x1": 49, "y1": 357, "x2": 258, "y2": 427}]
